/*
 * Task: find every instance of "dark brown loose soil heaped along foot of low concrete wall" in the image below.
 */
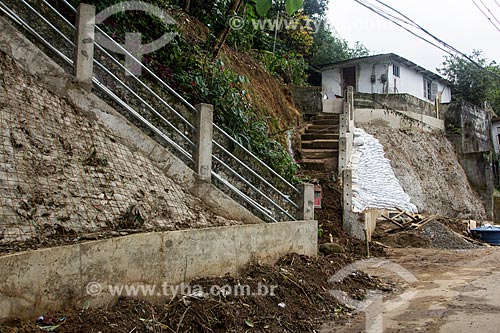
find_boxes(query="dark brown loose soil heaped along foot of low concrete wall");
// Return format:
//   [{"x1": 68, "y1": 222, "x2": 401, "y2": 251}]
[{"x1": 0, "y1": 254, "x2": 394, "y2": 333}]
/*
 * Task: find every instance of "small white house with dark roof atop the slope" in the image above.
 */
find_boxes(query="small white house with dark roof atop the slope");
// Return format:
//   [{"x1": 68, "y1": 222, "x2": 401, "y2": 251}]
[{"x1": 321, "y1": 53, "x2": 451, "y2": 103}]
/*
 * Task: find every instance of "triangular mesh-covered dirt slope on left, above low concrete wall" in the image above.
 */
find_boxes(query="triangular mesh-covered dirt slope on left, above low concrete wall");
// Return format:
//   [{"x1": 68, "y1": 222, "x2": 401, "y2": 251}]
[{"x1": 0, "y1": 53, "x2": 241, "y2": 252}]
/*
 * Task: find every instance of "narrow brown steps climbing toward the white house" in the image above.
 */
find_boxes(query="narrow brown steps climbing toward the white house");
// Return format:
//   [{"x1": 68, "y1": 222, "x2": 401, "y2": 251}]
[{"x1": 300, "y1": 113, "x2": 339, "y2": 171}]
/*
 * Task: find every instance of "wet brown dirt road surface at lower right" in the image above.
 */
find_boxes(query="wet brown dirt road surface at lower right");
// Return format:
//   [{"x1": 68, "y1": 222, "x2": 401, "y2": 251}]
[{"x1": 330, "y1": 248, "x2": 500, "y2": 333}]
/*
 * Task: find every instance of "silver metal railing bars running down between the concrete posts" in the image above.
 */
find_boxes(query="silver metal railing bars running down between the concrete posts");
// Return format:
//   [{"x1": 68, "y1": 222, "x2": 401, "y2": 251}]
[{"x1": 0, "y1": 0, "x2": 300, "y2": 222}]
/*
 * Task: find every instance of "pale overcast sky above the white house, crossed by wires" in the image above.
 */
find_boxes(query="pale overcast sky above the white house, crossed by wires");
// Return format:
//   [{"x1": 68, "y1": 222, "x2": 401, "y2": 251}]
[{"x1": 328, "y1": 0, "x2": 500, "y2": 72}]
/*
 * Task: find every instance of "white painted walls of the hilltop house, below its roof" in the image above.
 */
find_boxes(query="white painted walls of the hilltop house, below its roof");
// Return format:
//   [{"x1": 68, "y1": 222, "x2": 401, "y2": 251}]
[{"x1": 323, "y1": 61, "x2": 451, "y2": 103}]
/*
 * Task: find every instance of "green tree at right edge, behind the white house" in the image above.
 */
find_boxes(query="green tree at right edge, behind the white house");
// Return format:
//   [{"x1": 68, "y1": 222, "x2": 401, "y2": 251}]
[{"x1": 438, "y1": 50, "x2": 500, "y2": 114}]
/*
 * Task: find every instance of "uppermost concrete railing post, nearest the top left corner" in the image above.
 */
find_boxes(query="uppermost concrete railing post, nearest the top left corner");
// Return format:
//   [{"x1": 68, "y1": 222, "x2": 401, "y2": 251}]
[{"x1": 74, "y1": 3, "x2": 95, "y2": 90}]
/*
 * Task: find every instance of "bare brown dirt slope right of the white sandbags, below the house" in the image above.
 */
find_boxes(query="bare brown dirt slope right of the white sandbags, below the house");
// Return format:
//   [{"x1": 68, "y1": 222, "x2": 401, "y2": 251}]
[{"x1": 364, "y1": 126, "x2": 486, "y2": 219}]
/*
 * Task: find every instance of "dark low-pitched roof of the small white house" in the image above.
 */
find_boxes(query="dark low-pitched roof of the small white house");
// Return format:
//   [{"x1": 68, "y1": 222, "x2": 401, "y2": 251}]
[{"x1": 318, "y1": 53, "x2": 452, "y2": 85}]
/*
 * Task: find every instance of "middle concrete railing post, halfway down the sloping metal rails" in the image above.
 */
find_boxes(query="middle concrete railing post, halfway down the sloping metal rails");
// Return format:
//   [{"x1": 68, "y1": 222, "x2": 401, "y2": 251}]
[{"x1": 193, "y1": 104, "x2": 214, "y2": 182}]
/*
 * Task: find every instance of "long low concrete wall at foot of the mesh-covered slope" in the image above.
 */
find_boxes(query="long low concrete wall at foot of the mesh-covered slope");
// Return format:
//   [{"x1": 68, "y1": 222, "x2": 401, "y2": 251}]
[{"x1": 0, "y1": 221, "x2": 318, "y2": 320}]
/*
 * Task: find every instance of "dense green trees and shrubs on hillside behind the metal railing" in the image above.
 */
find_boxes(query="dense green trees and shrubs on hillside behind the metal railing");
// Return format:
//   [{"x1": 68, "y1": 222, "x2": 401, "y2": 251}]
[{"x1": 67, "y1": 0, "x2": 368, "y2": 181}]
